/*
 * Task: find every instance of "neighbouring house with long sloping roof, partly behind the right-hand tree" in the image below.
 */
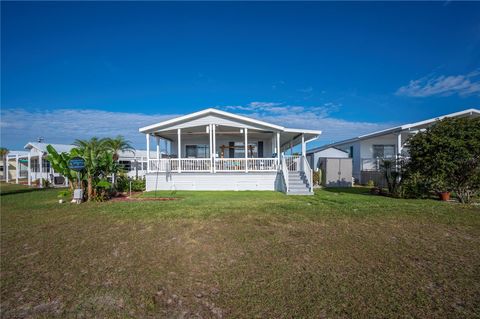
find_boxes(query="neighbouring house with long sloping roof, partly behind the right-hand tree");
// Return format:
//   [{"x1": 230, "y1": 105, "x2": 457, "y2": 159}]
[{"x1": 308, "y1": 109, "x2": 480, "y2": 184}]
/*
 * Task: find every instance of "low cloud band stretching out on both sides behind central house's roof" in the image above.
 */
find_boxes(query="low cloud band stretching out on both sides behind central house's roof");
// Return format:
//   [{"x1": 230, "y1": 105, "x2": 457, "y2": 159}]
[{"x1": 0, "y1": 102, "x2": 393, "y2": 149}]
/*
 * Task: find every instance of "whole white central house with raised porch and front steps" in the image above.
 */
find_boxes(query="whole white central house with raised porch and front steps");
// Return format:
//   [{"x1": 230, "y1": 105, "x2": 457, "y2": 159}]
[{"x1": 139, "y1": 108, "x2": 321, "y2": 194}]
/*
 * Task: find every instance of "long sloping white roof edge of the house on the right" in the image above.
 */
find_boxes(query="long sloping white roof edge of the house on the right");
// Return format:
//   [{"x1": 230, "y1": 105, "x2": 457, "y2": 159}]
[{"x1": 309, "y1": 109, "x2": 480, "y2": 152}]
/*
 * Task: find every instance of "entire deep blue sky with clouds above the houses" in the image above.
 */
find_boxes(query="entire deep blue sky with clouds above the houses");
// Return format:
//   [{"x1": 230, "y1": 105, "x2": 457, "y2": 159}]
[{"x1": 1, "y1": 2, "x2": 480, "y2": 149}]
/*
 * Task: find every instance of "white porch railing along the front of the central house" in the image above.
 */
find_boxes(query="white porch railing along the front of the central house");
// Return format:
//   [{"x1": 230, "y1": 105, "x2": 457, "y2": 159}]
[{"x1": 150, "y1": 158, "x2": 278, "y2": 172}]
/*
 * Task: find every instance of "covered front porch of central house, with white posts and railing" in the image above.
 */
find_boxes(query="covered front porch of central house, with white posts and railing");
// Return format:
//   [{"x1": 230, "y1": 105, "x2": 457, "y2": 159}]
[{"x1": 142, "y1": 124, "x2": 316, "y2": 173}]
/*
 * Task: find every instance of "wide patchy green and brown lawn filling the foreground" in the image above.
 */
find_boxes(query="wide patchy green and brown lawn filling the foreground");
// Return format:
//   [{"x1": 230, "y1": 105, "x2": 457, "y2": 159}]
[{"x1": 0, "y1": 184, "x2": 480, "y2": 318}]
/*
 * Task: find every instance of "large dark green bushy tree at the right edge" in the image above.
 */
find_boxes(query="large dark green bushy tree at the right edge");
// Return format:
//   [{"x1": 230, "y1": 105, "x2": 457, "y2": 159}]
[{"x1": 407, "y1": 118, "x2": 480, "y2": 203}]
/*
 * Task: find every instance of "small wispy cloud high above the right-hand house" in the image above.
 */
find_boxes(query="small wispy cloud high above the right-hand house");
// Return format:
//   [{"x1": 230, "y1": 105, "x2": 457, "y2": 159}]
[{"x1": 395, "y1": 70, "x2": 480, "y2": 97}]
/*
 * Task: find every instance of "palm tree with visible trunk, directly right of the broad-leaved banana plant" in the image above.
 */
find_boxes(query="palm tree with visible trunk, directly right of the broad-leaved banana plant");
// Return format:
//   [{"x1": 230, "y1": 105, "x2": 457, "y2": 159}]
[{"x1": 72, "y1": 137, "x2": 108, "y2": 200}]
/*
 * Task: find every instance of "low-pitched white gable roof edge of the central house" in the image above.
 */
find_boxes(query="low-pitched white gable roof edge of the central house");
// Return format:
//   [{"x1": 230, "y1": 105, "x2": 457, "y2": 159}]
[{"x1": 138, "y1": 108, "x2": 322, "y2": 135}]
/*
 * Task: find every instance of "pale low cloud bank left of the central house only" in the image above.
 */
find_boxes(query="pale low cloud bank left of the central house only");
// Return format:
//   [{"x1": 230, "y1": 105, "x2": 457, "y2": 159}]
[{"x1": 0, "y1": 108, "x2": 176, "y2": 149}]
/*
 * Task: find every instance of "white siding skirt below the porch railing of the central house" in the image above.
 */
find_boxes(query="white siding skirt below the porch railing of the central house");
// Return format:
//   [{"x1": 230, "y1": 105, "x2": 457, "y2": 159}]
[{"x1": 146, "y1": 172, "x2": 282, "y2": 191}]
